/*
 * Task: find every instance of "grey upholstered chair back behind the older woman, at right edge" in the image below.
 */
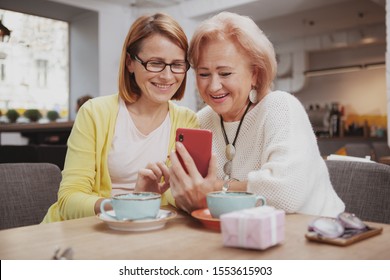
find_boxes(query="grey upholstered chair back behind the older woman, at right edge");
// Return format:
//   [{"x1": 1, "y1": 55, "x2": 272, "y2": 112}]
[{"x1": 325, "y1": 160, "x2": 390, "y2": 224}]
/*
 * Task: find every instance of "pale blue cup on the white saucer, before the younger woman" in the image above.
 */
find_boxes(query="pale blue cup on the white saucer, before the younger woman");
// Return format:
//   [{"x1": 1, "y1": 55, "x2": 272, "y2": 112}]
[{"x1": 100, "y1": 192, "x2": 161, "y2": 220}]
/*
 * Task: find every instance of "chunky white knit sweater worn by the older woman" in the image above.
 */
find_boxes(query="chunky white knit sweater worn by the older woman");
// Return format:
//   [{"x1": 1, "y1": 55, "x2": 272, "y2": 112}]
[{"x1": 198, "y1": 91, "x2": 345, "y2": 217}]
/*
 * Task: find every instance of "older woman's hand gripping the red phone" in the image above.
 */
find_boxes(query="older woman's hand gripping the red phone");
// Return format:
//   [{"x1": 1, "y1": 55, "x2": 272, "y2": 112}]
[{"x1": 169, "y1": 142, "x2": 218, "y2": 213}]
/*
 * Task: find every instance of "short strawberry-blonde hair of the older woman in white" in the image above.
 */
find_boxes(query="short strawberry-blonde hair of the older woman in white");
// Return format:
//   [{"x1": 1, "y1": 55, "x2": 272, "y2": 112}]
[{"x1": 188, "y1": 12, "x2": 277, "y2": 99}]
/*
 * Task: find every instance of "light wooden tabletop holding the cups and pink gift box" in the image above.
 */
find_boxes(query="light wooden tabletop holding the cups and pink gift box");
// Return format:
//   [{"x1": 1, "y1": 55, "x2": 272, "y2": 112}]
[{"x1": 0, "y1": 210, "x2": 390, "y2": 260}]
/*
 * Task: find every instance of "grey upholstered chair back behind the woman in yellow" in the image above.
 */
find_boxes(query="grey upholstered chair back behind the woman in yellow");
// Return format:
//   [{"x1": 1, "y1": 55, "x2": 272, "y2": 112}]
[{"x1": 0, "y1": 163, "x2": 62, "y2": 229}]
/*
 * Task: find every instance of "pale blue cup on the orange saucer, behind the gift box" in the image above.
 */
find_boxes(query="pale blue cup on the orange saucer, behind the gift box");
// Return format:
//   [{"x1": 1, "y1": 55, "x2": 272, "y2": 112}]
[{"x1": 206, "y1": 191, "x2": 266, "y2": 218}]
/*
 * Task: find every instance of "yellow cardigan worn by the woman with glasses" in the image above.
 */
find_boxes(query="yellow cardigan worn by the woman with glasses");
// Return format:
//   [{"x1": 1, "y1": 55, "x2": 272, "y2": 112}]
[{"x1": 43, "y1": 94, "x2": 199, "y2": 223}]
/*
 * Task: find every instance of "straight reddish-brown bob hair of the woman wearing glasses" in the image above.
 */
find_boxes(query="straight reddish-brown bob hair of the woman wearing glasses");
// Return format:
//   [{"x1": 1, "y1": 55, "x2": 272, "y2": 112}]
[{"x1": 118, "y1": 13, "x2": 188, "y2": 103}]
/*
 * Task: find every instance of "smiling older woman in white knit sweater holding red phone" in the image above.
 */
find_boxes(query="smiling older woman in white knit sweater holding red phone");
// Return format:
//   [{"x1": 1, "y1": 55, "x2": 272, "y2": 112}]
[{"x1": 170, "y1": 12, "x2": 345, "y2": 216}]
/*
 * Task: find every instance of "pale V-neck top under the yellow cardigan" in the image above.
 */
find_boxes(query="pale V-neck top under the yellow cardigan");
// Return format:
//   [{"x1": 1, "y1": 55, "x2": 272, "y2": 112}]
[{"x1": 108, "y1": 100, "x2": 171, "y2": 195}]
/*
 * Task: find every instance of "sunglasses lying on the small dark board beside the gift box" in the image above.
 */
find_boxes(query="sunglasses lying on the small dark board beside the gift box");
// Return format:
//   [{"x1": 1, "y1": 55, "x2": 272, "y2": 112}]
[{"x1": 309, "y1": 212, "x2": 369, "y2": 238}]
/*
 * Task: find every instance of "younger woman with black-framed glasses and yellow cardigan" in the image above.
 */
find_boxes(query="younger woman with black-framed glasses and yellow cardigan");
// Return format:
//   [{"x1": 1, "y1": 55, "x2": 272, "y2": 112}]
[{"x1": 44, "y1": 13, "x2": 198, "y2": 222}]
